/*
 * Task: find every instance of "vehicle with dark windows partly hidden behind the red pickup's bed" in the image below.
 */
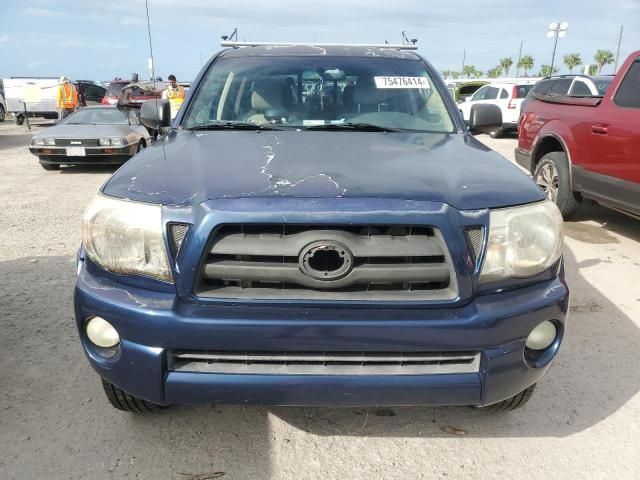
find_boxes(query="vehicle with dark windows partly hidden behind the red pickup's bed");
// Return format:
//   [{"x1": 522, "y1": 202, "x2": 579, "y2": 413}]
[{"x1": 520, "y1": 75, "x2": 613, "y2": 121}]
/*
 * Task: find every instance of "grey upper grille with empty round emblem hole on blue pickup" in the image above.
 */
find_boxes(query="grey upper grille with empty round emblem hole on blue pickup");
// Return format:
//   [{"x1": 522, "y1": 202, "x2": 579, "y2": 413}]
[{"x1": 196, "y1": 225, "x2": 457, "y2": 301}]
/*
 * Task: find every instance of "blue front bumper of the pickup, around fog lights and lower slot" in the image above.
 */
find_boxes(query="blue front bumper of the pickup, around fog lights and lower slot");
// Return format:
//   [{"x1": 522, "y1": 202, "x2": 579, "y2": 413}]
[{"x1": 75, "y1": 262, "x2": 568, "y2": 406}]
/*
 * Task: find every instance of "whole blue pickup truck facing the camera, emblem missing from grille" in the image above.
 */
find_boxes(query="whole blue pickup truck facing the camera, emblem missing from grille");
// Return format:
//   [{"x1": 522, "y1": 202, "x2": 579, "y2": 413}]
[{"x1": 75, "y1": 45, "x2": 569, "y2": 412}]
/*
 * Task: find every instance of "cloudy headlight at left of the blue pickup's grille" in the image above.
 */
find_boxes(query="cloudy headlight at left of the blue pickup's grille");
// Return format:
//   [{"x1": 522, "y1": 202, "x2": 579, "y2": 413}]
[{"x1": 82, "y1": 194, "x2": 173, "y2": 282}]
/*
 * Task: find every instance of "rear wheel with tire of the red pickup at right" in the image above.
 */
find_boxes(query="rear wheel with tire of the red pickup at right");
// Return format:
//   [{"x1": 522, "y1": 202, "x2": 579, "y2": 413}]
[{"x1": 533, "y1": 152, "x2": 582, "y2": 219}]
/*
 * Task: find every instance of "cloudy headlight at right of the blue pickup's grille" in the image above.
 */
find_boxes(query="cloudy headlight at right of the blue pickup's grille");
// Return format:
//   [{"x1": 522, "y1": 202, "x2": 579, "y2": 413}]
[{"x1": 480, "y1": 200, "x2": 564, "y2": 283}]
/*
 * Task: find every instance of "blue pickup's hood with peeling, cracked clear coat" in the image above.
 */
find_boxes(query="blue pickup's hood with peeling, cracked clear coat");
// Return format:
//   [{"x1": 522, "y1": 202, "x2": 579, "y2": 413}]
[{"x1": 103, "y1": 130, "x2": 544, "y2": 210}]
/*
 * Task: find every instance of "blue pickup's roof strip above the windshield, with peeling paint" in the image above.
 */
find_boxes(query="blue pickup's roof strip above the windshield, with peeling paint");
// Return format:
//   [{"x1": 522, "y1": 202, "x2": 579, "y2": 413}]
[{"x1": 220, "y1": 45, "x2": 420, "y2": 60}]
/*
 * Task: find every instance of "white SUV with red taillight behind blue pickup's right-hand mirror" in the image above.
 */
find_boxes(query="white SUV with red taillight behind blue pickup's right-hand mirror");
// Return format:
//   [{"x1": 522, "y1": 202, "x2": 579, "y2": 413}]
[{"x1": 459, "y1": 80, "x2": 536, "y2": 138}]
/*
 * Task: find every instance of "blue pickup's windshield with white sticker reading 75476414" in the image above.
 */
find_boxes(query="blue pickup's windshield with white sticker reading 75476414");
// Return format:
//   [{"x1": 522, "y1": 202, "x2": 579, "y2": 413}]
[{"x1": 183, "y1": 56, "x2": 454, "y2": 133}]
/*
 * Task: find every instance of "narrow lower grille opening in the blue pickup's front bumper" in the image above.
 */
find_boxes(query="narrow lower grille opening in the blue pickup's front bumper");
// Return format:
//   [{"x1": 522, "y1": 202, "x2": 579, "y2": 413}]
[{"x1": 169, "y1": 350, "x2": 480, "y2": 375}]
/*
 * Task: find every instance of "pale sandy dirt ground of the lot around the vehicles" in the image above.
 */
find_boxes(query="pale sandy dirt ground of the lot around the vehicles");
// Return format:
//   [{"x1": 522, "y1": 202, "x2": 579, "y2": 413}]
[{"x1": 0, "y1": 119, "x2": 640, "y2": 480}]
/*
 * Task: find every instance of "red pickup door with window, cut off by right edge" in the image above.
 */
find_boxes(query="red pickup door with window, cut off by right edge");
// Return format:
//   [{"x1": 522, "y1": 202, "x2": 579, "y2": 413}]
[{"x1": 584, "y1": 57, "x2": 640, "y2": 211}]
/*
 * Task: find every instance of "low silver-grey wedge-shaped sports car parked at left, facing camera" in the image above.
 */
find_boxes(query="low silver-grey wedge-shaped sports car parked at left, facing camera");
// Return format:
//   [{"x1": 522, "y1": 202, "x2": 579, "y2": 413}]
[{"x1": 29, "y1": 105, "x2": 151, "y2": 170}]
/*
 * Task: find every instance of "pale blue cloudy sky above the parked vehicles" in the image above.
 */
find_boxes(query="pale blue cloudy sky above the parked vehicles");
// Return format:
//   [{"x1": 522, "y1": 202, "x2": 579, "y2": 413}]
[{"x1": 0, "y1": 0, "x2": 640, "y2": 81}]
